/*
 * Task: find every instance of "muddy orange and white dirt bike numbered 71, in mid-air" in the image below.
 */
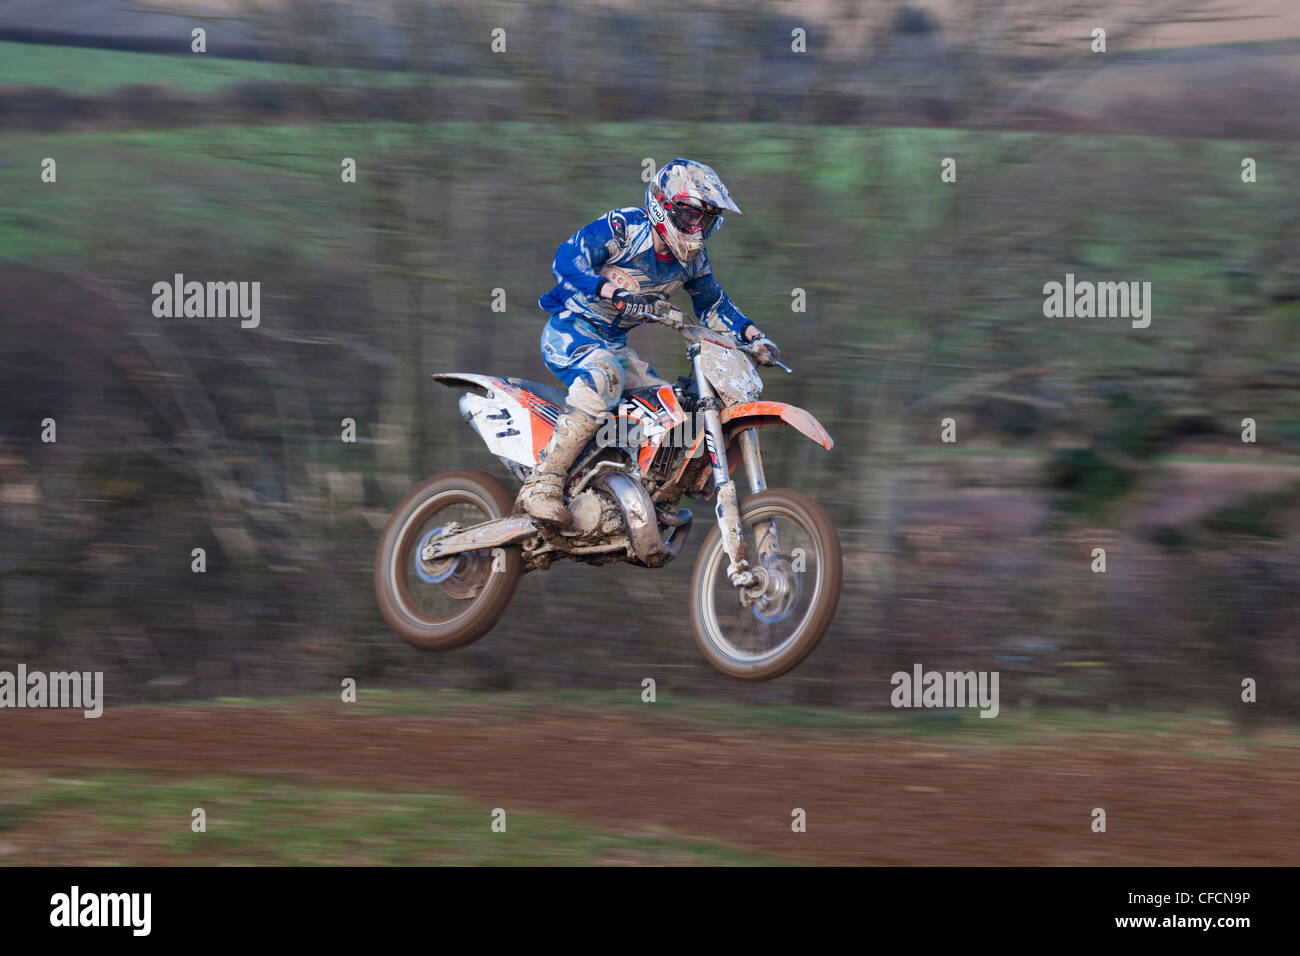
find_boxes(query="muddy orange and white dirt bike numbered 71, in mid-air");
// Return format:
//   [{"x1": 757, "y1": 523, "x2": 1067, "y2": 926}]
[{"x1": 374, "y1": 297, "x2": 842, "y2": 680}]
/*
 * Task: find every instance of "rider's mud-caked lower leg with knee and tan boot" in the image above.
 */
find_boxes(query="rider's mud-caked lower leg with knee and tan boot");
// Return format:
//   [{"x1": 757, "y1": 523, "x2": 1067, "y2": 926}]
[{"x1": 519, "y1": 349, "x2": 623, "y2": 527}]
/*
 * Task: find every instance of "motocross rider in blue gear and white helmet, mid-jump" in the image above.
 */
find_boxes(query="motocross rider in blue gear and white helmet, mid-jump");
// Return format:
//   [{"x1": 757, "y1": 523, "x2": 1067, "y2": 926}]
[{"x1": 519, "y1": 159, "x2": 780, "y2": 525}]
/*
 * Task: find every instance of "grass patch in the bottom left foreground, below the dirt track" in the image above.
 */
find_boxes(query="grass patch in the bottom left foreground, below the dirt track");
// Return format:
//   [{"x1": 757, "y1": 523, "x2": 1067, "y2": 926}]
[{"x1": 0, "y1": 771, "x2": 770, "y2": 866}]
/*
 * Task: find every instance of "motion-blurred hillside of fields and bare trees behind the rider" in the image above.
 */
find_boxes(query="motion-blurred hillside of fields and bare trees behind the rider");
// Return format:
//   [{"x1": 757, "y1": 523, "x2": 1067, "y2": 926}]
[{"x1": 0, "y1": 0, "x2": 1300, "y2": 719}]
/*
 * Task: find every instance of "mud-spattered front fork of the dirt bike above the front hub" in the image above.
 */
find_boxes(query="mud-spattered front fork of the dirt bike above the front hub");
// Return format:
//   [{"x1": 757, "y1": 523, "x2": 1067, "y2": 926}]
[{"x1": 690, "y1": 346, "x2": 780, "y2": 597}]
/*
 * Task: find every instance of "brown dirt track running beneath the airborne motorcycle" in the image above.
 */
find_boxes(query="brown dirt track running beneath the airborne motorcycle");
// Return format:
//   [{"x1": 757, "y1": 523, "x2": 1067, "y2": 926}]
[{"x1": 0, "y1": 704, "x2": 1300, "y2": 865}]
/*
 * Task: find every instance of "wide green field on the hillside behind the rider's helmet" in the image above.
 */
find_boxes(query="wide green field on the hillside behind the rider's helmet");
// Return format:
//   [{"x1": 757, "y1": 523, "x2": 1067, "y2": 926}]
[{"x1": 0, "y1": 122, "x2": 1300, "y2": 377}]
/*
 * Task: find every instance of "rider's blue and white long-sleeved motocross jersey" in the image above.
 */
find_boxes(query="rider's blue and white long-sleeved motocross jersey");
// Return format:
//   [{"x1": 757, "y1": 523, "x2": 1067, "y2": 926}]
[{"x1": 537, "y1": 207, "x2": 753, "y2": 342}]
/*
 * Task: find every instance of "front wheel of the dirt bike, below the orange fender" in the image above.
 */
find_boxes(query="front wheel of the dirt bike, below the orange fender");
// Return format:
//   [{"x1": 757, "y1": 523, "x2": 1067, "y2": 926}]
[{"x1": 690, "y1": 488, "x2": 844, "y2": 680}]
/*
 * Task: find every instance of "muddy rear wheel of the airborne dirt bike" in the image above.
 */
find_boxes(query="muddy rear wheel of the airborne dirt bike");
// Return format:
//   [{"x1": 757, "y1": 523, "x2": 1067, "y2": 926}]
[{"x1": 374, "y1": 470, "x2": 524, "y2": 650}]
